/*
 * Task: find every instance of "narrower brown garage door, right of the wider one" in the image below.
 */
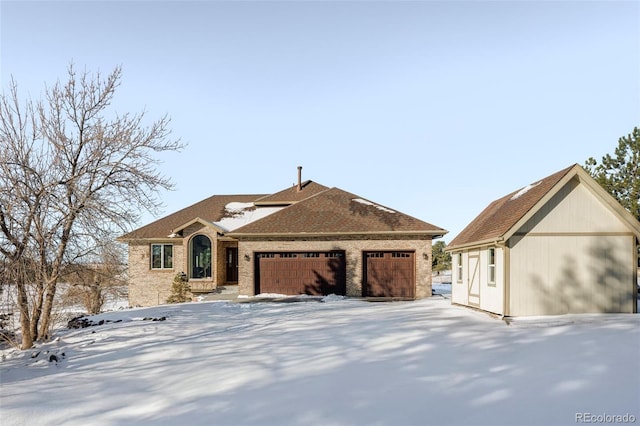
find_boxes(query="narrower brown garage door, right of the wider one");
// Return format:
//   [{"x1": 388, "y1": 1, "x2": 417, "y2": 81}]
[{"x1": 362, "y1": 251, "x2": 416, "y2": 298}]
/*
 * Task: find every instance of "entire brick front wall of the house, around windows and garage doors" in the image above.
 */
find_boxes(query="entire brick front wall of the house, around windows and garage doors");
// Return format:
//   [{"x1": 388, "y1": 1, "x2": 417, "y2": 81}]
[{"x1": 129, "y1": 233, "x2": 440, "y2": 306}]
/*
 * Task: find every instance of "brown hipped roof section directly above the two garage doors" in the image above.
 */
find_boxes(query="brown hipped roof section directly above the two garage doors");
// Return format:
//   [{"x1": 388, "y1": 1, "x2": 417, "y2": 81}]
[{"x1": 227, "y1": 188, "x2": 447, "y2": 237}]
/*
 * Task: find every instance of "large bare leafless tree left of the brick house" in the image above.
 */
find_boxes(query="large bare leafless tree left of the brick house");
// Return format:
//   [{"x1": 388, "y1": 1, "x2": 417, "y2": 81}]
[{"x1": 0, "y1": 65, "x2": 183, "y2": 349}]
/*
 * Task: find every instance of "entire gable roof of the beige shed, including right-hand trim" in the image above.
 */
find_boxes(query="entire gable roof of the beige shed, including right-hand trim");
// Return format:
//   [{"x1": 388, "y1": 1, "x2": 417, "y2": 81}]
[{"x1": 447, "y1": 164, "x2": 640, "y2": 251}]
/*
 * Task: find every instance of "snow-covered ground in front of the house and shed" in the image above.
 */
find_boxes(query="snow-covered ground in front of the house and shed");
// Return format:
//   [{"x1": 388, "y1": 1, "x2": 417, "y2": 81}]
[{"x1": 0, "y1": 286, "x2": 640, "y2": 426}]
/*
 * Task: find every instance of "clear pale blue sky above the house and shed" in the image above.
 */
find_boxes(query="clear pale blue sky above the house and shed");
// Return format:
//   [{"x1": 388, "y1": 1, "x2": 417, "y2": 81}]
[{"x1": 0, "y1": 0, "x2": 640, "y2": 242}]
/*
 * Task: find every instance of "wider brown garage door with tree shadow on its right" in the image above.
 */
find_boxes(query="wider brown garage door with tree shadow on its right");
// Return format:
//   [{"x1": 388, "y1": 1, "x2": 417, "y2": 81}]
[{"x1": 255, "y1": 251, "x2": 346, "y2": 295}]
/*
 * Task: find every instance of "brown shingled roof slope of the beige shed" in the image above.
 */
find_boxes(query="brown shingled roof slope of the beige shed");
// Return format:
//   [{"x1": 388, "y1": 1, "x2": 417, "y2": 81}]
[{"x1": 447, "y1": 164, "x2": 580, "y2": 250}]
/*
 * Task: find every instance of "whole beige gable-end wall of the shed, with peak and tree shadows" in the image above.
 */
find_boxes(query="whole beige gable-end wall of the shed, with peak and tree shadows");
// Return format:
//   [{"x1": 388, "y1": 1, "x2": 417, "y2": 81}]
[{"x1": 508, "y1": 180, "x2": 635, "y2": 316}]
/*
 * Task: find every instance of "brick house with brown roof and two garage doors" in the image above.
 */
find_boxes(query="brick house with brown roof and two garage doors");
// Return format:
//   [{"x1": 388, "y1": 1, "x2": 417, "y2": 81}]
[{"x1": 119, "y1": 168, "x2": 447, "y2": 306}]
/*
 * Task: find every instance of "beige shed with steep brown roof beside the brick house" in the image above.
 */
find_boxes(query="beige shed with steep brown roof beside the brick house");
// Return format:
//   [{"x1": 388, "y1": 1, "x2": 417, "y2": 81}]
[{"x1": 446, "y1": 164, "x2": 640, "y2": 316}]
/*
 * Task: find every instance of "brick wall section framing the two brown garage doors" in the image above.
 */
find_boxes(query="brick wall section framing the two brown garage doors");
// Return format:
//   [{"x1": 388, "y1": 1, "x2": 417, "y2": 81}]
[{"x1": 238, "y1": 236, "x2": 431, "y2": 298}]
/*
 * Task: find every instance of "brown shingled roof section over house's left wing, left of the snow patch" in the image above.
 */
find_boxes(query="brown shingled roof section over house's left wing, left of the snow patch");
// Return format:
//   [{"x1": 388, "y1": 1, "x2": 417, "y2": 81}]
[{"x1": 118, "y1": 194, "x2": 264, "y2": 241}]
